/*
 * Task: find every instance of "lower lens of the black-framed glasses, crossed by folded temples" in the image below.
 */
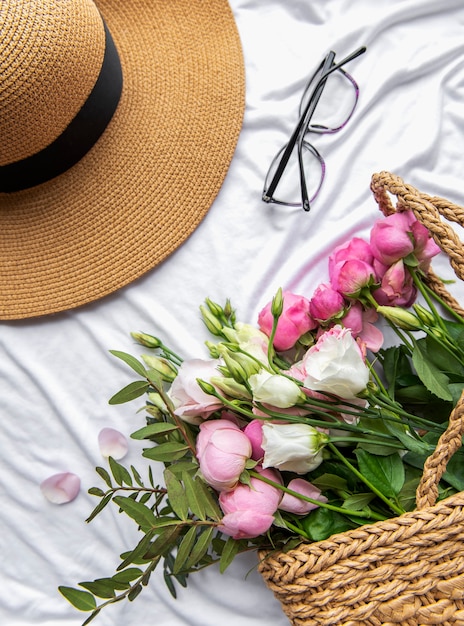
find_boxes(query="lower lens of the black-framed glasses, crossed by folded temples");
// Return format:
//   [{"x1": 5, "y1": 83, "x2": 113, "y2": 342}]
[{"x1": 265, "y1": 141, "x2": 325, "y2": 206}]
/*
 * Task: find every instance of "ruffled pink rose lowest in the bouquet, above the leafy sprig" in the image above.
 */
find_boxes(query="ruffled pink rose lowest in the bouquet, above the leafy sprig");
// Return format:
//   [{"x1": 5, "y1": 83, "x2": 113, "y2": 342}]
[{"x1": 219, "y1": 469, "x2": 282, "y2": 539}]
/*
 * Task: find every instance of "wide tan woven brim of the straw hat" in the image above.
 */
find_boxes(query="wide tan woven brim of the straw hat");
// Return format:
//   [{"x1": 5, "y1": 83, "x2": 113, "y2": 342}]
[{"x1": 0, "y1": 0, "x2": 245, "y2": 319}]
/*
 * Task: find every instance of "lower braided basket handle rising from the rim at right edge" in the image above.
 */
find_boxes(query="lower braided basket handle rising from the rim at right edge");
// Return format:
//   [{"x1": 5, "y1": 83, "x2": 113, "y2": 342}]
[{"x1": 416, "y1": 391, "x2": 464, "y2": 509}]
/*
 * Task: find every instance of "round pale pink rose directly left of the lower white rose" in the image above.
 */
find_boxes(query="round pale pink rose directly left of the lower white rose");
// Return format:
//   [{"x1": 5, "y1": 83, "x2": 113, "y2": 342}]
[{"x1": 197, "y1": 419, "x2": 251, "y2": 491}]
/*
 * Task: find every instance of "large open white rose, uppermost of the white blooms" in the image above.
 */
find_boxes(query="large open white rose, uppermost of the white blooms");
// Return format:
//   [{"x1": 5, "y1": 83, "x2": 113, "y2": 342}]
[{"x1": 303, "y1": 325, "x2": 369, "y2": 400}]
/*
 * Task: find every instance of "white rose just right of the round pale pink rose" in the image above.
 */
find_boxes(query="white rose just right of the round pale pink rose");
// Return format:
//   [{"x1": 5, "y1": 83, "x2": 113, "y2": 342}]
[{"x1": 261, "y1": 422, "x2": 327, "y2": 474}]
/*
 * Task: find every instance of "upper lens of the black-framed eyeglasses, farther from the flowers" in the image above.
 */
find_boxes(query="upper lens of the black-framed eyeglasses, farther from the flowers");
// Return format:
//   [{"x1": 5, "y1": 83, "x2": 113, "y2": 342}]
[{"x1": 300, "y1": 69, "x2": 358, "y2": 133}]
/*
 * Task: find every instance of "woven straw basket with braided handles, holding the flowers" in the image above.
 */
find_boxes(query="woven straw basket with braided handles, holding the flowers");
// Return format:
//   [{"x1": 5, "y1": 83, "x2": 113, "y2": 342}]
[{"x1": 259, "y1": 172, "x2": 464, "y2": 626}]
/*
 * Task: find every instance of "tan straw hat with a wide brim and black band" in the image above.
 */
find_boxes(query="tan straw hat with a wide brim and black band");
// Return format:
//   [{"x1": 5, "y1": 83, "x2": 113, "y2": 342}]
[{"x1": 0, "y1": 0, "x2": 244, "y2": 320}]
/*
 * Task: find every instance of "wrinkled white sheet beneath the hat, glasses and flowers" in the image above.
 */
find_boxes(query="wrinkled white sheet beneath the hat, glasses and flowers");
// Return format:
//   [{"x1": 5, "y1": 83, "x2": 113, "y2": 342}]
[{"x1": 0, "y1": 0, "x2": 464, "y2": 626}]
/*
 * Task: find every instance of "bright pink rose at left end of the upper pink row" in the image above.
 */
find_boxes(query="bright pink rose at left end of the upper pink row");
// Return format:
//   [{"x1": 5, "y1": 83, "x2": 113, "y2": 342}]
[{"x1": 258, "y1": 291, "x2": 317, "y2": 351}]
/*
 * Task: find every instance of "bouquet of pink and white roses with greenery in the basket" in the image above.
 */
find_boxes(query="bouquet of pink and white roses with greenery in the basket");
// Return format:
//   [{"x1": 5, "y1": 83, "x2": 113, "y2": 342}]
[{"x1": 60, "y1": 194, "x2": 464, "y2": 624}]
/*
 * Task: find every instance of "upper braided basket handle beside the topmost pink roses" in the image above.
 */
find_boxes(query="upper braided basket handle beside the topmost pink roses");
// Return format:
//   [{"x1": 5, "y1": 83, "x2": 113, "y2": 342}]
[{"x1": 371, "y1": 172, "x2": 464, "y2": 317}]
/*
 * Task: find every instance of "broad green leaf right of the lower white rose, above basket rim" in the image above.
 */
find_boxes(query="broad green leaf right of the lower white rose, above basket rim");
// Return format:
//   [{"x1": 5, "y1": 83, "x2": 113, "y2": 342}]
[{"x1": 354, "y1": 448, "x2": 404, "y2": 498}]
